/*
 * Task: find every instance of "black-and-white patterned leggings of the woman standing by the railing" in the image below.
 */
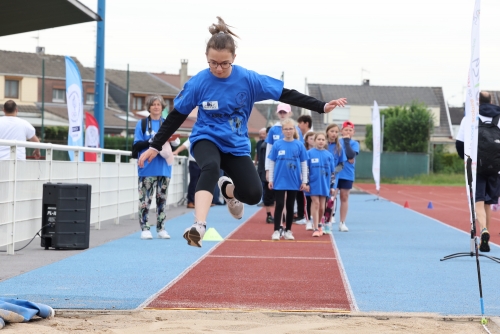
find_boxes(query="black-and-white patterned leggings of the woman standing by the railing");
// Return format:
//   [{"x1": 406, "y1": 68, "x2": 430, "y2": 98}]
[{"x1": 139, "y1": 176, "x2": 170, "y2": 231}]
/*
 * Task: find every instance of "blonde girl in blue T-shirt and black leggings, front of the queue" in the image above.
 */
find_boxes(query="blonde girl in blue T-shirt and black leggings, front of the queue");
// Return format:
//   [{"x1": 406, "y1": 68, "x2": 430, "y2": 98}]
[{"x1": 268, "y1": 118, "x2": 307, "y2": 240}]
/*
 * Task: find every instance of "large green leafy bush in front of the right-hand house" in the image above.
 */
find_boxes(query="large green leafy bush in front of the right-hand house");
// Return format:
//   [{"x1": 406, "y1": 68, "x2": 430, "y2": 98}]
[{"x1": 365, "y1": 101, "x2": 434, "y2": 153}]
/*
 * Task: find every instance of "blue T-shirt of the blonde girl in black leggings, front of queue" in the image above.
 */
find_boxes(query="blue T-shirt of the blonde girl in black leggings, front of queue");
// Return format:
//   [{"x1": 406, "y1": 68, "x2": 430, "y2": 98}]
[{"x1": 268, "y1": 139, "x2": 307, "y2": 190}]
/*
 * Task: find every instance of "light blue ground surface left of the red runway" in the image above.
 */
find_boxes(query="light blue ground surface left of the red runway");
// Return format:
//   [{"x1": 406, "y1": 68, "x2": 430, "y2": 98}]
[{"x1": 0, "y1": 206, "x2": 260, "y2": 310}]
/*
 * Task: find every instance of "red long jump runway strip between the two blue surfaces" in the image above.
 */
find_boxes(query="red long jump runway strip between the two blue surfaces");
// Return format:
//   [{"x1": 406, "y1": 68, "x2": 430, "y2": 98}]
[{"x1": 147, "y1": 209, "x2": 353, "y2": 312}]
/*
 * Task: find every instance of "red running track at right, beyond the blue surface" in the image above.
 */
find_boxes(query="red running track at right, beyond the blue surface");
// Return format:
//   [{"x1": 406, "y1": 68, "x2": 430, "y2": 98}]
[{"x1": 356, "y1": 183, "x2": 500, "y2": 245}]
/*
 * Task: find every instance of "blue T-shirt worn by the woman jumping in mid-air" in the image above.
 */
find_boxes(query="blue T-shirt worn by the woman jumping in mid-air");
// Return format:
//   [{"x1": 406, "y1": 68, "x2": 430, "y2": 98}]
[{"x1": 174, "y1": 65, "x2": 283, "y2": 158}]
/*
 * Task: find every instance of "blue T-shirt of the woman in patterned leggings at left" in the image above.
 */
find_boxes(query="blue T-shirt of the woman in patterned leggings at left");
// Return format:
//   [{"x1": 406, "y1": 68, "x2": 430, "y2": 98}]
[{"x1": 134, "y1": 120, "x2": 172, "y2": 177}]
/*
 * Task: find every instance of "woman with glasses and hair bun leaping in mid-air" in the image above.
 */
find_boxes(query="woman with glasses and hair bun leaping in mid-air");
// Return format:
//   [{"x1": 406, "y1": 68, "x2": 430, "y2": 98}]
[{"x1": 138, "y1": 17, "x2": 346, "y2": 247}]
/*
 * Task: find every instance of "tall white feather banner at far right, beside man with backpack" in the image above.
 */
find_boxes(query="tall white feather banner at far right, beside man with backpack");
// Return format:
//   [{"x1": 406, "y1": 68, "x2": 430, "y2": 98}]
[{"x1": 464, "y1": 0, "x2": 481, "y2": 219}]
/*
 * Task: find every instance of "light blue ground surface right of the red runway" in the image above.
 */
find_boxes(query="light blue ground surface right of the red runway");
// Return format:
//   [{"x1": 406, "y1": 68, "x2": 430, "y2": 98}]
[{"x1": 334, "y1": 195, "x2": 500, "y2": 316}]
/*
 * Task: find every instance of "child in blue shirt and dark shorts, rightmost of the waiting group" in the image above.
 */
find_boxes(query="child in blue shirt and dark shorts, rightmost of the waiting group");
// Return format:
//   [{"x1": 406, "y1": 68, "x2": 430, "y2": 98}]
[{"x1": 337, "y1": 121, "x2": 359, "y2": 232}]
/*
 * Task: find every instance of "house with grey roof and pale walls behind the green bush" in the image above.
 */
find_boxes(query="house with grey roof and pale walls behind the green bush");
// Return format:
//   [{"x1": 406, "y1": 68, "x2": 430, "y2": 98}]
[{"x1": 308, "y1": 80, "x2": 454, "y2": 148}]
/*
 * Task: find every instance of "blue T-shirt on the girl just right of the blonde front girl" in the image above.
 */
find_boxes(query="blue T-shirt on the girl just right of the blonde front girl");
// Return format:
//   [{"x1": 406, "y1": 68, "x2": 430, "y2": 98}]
[{"x1": 306, "y1": 148, "x2": 335, "y2": 196}]
